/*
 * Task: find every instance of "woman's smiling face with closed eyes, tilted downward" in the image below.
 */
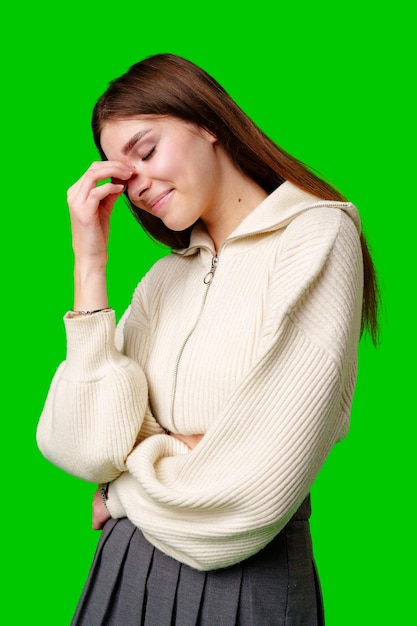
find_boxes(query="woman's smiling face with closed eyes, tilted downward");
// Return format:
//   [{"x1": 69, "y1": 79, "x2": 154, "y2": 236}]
[{"x1": 100, "y1": 116, "x2": 222, "y2": 231}]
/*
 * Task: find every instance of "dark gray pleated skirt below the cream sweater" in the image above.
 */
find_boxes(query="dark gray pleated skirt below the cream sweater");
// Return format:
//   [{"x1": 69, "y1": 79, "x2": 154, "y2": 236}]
[{"x1": 71, "y1": 498, "x2": 324, "y2": 626}]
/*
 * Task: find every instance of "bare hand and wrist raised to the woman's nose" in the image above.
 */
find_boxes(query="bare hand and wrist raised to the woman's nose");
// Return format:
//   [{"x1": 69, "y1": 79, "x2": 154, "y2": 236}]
[{"x1": 68, "y1": 161, "x2": 134, "y2": 310}]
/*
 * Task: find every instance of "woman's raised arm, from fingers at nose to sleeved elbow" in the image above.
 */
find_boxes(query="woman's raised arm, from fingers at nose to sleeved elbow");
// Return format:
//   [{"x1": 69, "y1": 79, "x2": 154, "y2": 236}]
[{"x1": 37, "y1": 162, "x2": 161, "y2": 482}]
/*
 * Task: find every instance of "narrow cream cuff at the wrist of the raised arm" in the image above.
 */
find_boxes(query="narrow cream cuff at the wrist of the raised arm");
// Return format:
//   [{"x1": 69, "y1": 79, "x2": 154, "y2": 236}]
[{"x1": 64, "y1": 311, "x2": 129, "y2": 381}]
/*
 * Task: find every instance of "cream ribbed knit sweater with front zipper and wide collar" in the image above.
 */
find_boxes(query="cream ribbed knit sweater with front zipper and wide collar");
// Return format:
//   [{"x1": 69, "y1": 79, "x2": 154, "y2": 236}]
[{"x1": 37, "y1": 182, "x2": 363, "y2": 570}]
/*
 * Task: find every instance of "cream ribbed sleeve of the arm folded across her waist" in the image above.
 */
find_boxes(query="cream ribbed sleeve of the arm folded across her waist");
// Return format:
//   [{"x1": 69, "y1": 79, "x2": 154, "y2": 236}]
[{"x1": 108, "y1": 211, "x2": 363, "y2": 570}]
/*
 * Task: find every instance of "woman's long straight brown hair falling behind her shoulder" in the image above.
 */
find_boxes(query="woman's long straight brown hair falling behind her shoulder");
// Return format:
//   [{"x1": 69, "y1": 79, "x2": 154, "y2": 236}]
[{"x1": 92, "y1": 54, "x2": 379, "y2": 344}]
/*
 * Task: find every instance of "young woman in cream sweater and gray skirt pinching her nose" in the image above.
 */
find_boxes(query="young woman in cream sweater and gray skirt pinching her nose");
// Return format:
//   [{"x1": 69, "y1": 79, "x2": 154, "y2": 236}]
[{"x1": 38, "y1": 55, "x2": 376, "y2": 626}]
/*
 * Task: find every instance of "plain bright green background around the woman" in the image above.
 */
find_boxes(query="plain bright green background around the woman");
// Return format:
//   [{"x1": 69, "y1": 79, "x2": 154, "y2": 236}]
[{"x1": 0, "y1": 0, "x2": 416, "y2": 626}]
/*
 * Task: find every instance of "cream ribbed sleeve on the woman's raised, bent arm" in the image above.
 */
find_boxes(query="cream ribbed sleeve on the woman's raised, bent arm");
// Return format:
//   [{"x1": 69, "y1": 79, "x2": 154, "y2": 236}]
[{"x1": 37, "y1": 312, "x2": 162, "y2": 482}]
